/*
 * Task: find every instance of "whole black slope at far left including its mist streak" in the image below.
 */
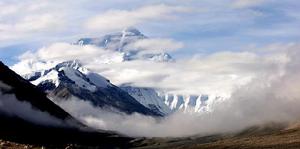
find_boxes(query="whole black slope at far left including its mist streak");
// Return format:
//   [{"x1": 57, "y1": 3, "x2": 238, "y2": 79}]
[{"x1": 0, "y1": 62, "x2": 131, "y2": 148}]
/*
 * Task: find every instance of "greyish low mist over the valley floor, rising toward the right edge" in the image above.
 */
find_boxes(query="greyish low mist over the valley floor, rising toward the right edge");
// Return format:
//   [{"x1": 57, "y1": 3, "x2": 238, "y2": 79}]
[{"x1": 54, "y1": 44, "x2": 300, "y2": 137}]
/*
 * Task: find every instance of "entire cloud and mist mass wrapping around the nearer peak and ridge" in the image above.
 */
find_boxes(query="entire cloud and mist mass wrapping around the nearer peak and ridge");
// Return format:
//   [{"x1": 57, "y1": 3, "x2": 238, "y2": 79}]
[{"x1": 8, "y1": 43, "x2": 300, "y2": 137}]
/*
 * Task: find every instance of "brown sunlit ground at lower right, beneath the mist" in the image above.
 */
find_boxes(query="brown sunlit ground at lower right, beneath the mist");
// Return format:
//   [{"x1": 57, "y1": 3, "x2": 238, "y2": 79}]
[{"x1": 135, "y1": 125, "x2": 300, "y2": 149}]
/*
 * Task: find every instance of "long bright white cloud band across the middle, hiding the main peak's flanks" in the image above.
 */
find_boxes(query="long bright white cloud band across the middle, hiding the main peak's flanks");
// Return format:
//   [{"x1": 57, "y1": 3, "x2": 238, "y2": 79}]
[{"x1": 13, "y1": 43, "x2": 297, "y2": 97}]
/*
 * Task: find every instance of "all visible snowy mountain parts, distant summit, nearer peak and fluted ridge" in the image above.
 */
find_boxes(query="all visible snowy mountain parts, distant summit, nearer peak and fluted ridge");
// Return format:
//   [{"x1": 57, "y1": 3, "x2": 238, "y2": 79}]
[{"x1": 12, "y1": 28, "x2": 223, "y2": 115}]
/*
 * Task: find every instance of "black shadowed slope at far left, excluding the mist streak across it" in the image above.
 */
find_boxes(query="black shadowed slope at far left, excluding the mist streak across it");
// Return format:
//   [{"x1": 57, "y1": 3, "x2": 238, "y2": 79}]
[{"x1": 0, "y1": 62, "x2": 132, "y2": 148}]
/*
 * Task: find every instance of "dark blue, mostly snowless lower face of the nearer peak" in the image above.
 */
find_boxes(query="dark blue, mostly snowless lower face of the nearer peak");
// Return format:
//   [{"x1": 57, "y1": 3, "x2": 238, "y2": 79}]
[{"x1": 52, "y1": 83, "x2": 162, "y2": 116}]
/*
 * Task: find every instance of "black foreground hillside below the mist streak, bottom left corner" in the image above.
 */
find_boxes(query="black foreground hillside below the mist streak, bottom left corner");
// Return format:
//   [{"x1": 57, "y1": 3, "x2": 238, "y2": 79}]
[{"x1": 0, "y1": 113, "x2": 131, "y2": 148}]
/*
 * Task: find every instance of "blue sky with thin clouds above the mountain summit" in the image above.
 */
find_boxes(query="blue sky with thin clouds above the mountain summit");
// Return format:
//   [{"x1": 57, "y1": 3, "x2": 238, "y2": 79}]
[{"x1": 0, "y1": 0, "x2": 300, "y2": 65}]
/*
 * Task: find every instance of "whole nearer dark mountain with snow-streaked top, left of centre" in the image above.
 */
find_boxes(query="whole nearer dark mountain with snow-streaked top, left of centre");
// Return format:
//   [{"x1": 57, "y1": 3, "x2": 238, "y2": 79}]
[{"x1": 24, "y1": 61, "x2": 162, "y2": 116}]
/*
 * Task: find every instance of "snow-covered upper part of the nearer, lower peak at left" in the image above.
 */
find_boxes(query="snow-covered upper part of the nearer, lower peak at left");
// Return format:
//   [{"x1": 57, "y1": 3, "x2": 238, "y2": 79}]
[{"x1": 24, "y1": 60, "x2": 111, "y2": 92}]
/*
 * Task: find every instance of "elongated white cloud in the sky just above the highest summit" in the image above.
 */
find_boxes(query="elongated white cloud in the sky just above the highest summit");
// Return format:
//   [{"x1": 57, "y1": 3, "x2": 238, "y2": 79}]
[{"x1": 86, "y1": 4, "x2": 190, "y2": 31}]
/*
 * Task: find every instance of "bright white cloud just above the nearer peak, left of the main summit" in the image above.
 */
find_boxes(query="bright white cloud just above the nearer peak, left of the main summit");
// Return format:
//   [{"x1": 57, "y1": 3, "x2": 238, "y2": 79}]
[{"x1": 11, "y1": 42, "x2": 123, "y2": 75}]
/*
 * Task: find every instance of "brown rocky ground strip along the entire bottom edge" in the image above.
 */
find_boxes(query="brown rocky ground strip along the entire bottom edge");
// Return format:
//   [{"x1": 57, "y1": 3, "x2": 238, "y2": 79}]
[{"x1": 0, "y1": 122, "x2": 300, "y2": 149}]
